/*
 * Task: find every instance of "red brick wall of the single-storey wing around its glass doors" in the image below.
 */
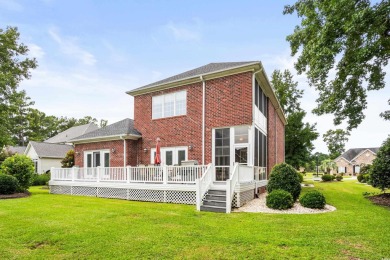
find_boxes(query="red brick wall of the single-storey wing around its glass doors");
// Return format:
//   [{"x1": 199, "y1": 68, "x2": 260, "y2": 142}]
[{"x1": 74, "y1": 140, "x2": 138, "y2": 167}]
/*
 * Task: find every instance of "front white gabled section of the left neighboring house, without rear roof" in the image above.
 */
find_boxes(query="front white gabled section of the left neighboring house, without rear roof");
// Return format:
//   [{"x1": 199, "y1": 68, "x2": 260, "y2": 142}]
[{"x1": 24, "y1": 141, "x2": 73, "y2": 174}]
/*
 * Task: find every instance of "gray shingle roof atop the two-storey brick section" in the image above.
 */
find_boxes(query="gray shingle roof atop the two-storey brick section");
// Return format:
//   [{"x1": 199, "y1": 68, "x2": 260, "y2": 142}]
[{"x1": 127, "y1": 61, "x2": 260, "y2": 93}]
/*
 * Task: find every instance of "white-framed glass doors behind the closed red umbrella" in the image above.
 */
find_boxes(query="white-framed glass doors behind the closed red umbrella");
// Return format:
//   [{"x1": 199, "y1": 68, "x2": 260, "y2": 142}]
[{"x1": 150, "y1": 146, "x2": 188, "y2": 165}]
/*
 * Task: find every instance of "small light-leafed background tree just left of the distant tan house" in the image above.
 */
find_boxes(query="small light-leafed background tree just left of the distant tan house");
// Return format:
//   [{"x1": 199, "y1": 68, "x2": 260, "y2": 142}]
[{"x1": 322, "y1": 129, "x2": 349, "y2": 160}]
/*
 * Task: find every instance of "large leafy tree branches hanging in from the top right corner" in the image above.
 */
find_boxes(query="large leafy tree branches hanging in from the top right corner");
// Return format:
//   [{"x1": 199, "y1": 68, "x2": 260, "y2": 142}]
[{"x1": 283, "y1": 0, "x2": 390, "y2": 130}]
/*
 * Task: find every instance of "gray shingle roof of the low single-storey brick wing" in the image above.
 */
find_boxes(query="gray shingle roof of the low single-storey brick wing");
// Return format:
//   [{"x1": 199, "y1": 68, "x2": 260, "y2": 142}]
[{"x1": 71, "y1": 118, "x2": 141, "y2": 141}]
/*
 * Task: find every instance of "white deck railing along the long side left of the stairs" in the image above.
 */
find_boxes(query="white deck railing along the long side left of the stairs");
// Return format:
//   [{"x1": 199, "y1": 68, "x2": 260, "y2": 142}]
[{"x1": 51, "y1": 165, "x2": 207, "y2": 184}]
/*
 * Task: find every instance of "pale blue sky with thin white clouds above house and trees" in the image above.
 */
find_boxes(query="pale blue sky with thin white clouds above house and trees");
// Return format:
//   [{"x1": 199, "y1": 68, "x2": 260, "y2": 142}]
[{"x1": 0, "y1": 0, "x2": 390, "y2": 152}]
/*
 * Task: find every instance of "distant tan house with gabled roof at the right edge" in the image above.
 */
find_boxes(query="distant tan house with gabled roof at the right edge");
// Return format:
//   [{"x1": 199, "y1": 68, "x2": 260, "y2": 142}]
[{"x1": 334, "y1": 147, "x2": 379, "y2": 175}]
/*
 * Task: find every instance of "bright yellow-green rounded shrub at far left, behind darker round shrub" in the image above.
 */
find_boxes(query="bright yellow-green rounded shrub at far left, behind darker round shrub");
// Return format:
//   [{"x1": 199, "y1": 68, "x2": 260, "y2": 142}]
[{"x1": 1, "y1": 154, "x2": 35, "y2": 191}]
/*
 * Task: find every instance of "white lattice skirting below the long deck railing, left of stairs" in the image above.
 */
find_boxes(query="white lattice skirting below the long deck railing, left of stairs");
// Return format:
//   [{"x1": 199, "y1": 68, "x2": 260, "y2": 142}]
[{"x1": 50, "y1": 185, "x2": 196, "y2": 204}]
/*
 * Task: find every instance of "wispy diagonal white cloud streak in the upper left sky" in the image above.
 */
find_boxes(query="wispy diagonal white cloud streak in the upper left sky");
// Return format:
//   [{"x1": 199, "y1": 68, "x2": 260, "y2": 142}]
[{"x1": 49, "y1": 28, "x2": 96, "y2": 66}]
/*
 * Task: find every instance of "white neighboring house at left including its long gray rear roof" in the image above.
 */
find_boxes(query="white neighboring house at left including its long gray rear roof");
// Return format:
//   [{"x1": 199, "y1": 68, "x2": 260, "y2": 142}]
[{"x1": 24, "y1": 123, "x2": 99, "y2": 174}]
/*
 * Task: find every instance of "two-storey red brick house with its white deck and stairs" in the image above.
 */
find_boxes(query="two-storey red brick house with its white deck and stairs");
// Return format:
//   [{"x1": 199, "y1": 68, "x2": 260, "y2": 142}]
[{"x1": 50, "y1": 61, "x2": 287, "y2": 212}]
